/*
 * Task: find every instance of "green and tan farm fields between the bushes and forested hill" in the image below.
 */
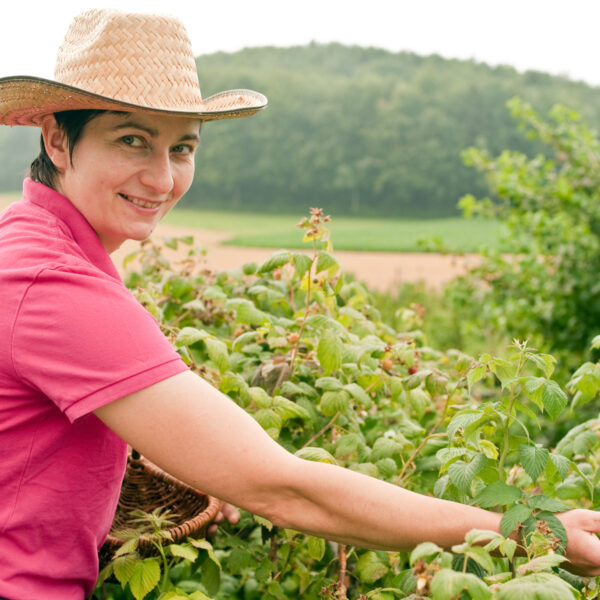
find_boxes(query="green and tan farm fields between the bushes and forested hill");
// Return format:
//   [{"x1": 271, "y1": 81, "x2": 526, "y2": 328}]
[{"x1": 0, "y1": 193, "x2": 492, "y2": 291}]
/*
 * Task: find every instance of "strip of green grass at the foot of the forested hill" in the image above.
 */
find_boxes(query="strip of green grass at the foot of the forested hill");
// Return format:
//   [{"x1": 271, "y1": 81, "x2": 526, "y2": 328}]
[{"x1": 165, "y1": 209, "x2": 500, "y2": 252}]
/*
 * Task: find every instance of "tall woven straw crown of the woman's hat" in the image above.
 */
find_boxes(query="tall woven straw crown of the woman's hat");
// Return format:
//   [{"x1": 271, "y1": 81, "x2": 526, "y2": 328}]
[{"x1": 54, "y1": 9, "x2": 203, "y2": 111}]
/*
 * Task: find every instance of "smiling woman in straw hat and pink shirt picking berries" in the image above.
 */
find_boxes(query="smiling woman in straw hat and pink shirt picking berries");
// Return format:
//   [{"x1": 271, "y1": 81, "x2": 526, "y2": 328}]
[{"x1": 0, "y1": 10, "x2": 600, "y2": 600}]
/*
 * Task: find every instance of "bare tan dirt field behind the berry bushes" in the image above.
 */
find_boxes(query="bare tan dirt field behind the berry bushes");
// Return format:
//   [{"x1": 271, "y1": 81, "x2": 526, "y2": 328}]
[{"x1": 112, "y1": 224, "x2": 477, "y2": 291}]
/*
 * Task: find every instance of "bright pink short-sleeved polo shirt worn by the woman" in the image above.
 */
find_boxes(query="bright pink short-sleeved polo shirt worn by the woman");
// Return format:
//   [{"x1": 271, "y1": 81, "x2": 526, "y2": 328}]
[{"x1": 0, "y1": 179, "x2": 187, "y2": 600}]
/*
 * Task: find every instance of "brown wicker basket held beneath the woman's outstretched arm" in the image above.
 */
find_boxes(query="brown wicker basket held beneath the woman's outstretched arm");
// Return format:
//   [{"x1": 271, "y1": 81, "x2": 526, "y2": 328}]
[{"x1": 100, "y1": 450, "x2": 220, "y2": 566}]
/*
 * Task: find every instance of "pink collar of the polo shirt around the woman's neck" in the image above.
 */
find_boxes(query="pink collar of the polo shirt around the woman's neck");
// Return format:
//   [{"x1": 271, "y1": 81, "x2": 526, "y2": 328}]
[{"x1": 23, "y1": 177, "x2": 121, "y2": 281}]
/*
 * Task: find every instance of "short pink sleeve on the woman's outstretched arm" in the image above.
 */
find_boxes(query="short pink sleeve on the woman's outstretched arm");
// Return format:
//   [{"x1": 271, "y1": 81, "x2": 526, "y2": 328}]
[{"x1": 11, "y1": 268, "x2": 187, "y2": 421}]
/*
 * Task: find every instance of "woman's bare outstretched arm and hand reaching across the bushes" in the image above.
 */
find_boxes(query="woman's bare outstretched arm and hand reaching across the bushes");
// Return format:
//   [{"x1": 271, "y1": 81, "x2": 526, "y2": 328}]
[{"x1": 95, "y1": 372, "x2": 600, "y2": 574}]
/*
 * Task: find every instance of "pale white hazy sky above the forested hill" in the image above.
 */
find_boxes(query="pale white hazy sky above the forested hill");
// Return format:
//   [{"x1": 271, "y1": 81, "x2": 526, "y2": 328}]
[{"x1": 0, "y1": 0, "x2": 600, "y2": 86}]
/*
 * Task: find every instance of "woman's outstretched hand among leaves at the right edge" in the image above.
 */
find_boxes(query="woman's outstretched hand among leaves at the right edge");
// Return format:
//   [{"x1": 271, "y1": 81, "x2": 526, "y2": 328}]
[{"x1": 556, "y1": 509, "x2": 600, "y2": 577}]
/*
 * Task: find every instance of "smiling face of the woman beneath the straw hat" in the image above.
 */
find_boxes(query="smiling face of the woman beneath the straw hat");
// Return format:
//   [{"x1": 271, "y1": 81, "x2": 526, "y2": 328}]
[{"x1": 42, "y1": 112, "x2": 200, "y2": 253}]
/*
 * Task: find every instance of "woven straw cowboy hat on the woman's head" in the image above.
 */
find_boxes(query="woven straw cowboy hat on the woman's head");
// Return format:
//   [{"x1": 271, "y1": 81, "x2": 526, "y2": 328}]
[{"x1": 0, "y1": 9, "x2": 267, "y2": 125}]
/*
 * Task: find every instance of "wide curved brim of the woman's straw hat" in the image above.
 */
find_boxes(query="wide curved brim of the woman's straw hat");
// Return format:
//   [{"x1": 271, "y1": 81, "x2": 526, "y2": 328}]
[{"x1": 0, "y1": 75, "x2": 267, "y2": 126}]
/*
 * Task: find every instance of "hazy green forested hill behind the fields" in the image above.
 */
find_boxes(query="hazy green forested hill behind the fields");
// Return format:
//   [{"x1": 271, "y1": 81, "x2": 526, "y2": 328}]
[{"x1": 0, "y1": 41, "x2": 600, "y2": 217}]
